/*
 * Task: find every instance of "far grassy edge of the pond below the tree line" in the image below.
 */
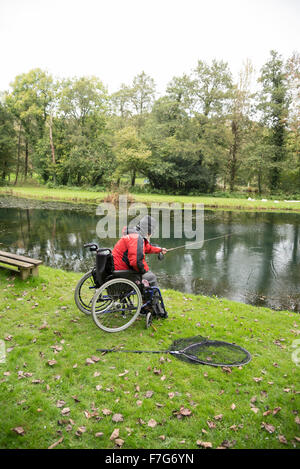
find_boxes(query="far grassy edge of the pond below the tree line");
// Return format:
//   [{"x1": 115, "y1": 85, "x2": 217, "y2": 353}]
[{"x1": 0, "y1": 187, "x2": 300, "y2": 213}]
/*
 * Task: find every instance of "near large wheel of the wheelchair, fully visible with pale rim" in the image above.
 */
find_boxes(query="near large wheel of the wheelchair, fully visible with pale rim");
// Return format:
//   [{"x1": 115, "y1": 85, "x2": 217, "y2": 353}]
[{"x1": 92, "y1": 278, "x2": 143, "y2": 332}]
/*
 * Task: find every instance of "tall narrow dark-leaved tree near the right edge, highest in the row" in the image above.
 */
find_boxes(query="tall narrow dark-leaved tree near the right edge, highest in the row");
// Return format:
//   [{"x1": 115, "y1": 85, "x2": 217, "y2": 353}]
[{"x1": 258, "y1": 50, "x2": 289, "y2": 190}]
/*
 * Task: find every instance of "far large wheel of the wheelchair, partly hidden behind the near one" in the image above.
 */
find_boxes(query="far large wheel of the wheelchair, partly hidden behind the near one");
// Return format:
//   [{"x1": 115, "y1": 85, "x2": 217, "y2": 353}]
[{"x1": 74, "y1": 270, "x2": 109, "y2": 316}]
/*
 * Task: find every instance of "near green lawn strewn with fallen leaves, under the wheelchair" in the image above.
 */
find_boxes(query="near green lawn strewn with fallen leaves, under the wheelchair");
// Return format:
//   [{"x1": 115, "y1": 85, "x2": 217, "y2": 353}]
[{"x1": 0, "y1": 266, "x2": 300, "y2": 449}]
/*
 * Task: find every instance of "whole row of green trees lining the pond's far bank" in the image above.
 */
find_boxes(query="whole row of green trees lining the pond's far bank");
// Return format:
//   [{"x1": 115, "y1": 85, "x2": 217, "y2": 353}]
[{"x1": 0, "y1": 51, "x2": 300, "y2": 194}]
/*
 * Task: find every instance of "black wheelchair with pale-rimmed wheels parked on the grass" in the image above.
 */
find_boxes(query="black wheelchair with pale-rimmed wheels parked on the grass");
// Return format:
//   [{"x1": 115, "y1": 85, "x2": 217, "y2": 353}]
[{"x1": 74, "y1": 243, "x2": 167, "y2": 332}]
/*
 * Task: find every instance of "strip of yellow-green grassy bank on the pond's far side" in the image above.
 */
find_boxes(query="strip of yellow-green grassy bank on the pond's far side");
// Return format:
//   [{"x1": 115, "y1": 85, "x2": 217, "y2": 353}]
[{"x1": 0, "y1": 186, "x2": 300, "y2": 212}]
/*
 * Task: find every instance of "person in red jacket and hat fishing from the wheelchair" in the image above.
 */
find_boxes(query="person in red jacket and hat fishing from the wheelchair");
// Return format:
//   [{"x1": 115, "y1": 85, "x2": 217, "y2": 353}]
[{"x1": 112, "y1": 215, "x2": 167, "y2": 317}]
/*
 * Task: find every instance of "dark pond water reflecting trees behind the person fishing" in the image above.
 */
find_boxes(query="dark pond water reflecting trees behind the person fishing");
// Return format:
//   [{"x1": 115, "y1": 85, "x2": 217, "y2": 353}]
[{"x1": 0, "y1": 196, "x2": 300, "y2": 312}]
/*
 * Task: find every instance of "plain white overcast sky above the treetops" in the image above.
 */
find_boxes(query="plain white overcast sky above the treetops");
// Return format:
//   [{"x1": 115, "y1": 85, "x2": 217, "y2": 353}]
[{"x1": 0, "y1": 0, "x2": 300, "y2": 93}]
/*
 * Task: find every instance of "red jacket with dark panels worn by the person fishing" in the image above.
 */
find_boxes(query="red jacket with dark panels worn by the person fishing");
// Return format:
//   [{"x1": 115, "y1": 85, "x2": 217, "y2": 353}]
[{"x1": 112, "y1": 228, "x2": 161, "y2": 274}]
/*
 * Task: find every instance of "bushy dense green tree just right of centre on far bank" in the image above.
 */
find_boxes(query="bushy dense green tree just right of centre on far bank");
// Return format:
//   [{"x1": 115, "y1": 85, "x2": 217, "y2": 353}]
[{"x1": 143, "y1": 96, "x2": 215, "y2": 193}]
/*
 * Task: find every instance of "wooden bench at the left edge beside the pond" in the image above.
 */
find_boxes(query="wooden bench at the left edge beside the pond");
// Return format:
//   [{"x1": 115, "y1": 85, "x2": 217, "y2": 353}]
[{"x1": 0, "y1": 251, "x2": 43, "y2": 280}]
